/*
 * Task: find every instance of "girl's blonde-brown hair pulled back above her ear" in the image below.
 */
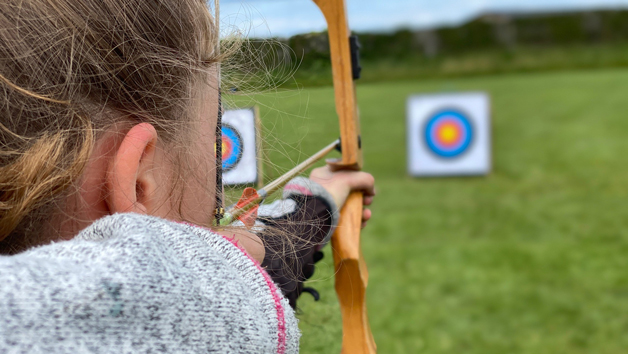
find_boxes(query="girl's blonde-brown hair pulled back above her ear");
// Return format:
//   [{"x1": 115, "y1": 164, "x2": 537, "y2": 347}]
[{"x1": 0, "y1": 0, "x2": 221, "y2": 253}]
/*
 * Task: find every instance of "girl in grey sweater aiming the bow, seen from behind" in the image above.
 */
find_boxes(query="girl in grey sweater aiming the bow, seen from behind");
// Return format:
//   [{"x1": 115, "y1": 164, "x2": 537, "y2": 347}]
[{"x1": 0, "y1": 0, "x2": 373, "y2": 353}]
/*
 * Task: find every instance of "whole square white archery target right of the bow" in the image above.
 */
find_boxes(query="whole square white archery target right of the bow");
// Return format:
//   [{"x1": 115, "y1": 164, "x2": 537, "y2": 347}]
[{"x1": 407, "y1": 92, "x2": 491, "y2": 176}]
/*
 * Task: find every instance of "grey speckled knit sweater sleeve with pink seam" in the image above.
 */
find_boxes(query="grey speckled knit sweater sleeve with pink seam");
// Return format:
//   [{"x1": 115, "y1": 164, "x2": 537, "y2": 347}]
[{"x1": 0, "y1": 214, "x2": 299, "y2": 353}]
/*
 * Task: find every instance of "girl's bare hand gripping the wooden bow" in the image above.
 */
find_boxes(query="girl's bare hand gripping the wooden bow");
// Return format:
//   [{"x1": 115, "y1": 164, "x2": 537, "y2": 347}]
[{"x1": 310, "y1": 165, "x2": 375, "y2": 227}]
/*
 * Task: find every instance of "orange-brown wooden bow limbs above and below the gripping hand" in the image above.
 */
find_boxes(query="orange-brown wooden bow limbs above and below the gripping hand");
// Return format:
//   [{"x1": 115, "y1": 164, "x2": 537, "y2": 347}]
[{"x1": 313, "y1": 0, "x2": 376, "y2": 354}]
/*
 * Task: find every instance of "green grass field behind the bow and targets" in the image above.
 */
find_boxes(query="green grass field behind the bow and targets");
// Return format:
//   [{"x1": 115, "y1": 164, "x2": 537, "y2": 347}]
[{"x1": 231, "y1": 70, "x2": 628, "y2": 354}]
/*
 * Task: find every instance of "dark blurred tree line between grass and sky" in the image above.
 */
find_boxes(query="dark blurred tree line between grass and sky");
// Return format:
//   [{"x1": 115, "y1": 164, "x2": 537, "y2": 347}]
[{"x1": 248, "y1": 11, "x2": 628, "y2": 69}]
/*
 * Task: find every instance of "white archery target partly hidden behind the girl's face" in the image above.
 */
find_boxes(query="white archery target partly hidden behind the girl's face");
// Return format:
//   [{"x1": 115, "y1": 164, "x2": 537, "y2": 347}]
[{"x1": 222, "y1": 108, "x2": 261, "y2": 185}]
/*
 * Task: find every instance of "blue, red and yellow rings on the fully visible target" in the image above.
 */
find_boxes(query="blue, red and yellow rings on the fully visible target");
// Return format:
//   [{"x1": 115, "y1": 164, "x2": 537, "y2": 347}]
[{"x1": 424, "y1": 109, "x2": 473, "y2": 158}]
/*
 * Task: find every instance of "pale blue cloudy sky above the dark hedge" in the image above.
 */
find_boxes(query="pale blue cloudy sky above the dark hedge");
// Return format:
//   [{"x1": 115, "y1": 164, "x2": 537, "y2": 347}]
[{"x1": 220, "y1": 0, "x2": 628, "y2": 37}]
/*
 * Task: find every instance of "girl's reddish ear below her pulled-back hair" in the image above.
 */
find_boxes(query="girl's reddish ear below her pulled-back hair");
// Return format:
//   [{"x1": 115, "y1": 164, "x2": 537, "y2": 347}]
[{"x1": 107, "y1": 123, "x2": 157, "y2": 214}]
